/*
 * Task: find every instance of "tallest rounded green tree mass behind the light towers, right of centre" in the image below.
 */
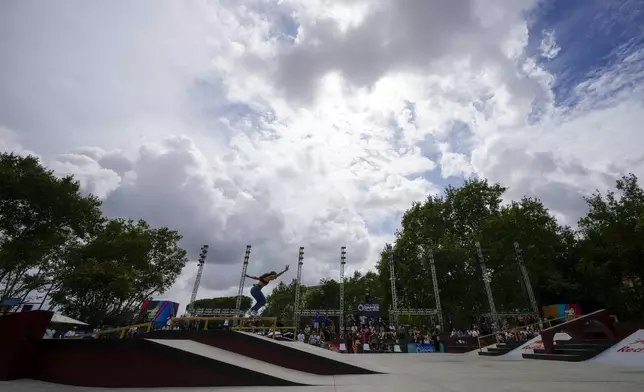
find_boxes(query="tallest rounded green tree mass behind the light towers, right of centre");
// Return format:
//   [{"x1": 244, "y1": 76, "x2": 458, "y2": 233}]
[{"x1": 376, "y1": 179, "x2": 574, "y2": 325}]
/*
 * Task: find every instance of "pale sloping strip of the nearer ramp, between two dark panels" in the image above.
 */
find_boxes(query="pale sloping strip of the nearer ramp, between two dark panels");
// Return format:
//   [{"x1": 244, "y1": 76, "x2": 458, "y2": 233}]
[{"x1": 151, "y1": 339, "x2": 334, "y2": 386}]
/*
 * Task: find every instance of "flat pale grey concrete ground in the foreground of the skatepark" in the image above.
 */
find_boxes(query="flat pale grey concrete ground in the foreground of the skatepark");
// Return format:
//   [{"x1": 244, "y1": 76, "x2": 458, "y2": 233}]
[{"x1": 0, "y1": 354, "x2": 644, "y2": 392}]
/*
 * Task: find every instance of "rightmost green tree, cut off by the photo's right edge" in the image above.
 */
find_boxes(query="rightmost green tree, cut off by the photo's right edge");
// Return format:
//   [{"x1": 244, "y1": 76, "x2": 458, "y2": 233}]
[{"x1": 576, "y1": 174, "x2": 644, "y2": 319}]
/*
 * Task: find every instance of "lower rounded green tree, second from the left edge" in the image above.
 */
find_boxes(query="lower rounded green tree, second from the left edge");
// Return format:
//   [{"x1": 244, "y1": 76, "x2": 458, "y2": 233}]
[{"x1": 52, "y1": 219, "x2": 187, "y2": 324}]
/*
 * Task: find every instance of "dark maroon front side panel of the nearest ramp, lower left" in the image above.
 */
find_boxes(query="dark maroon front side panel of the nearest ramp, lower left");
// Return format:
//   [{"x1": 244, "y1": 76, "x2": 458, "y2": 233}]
[{"x1": 36, "y1": 339, "x2": 300, "y2": 388}]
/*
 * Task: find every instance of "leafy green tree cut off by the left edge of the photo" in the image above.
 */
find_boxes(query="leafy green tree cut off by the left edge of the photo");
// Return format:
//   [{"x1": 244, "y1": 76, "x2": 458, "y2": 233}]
[{"x1": 0, "y1": 153, "x2": 103, "y2": 300}]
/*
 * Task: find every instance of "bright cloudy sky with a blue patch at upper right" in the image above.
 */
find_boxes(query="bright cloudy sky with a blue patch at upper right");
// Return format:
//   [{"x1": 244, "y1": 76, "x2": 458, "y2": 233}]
[{"x1": 0, "y1": 0, "x2": 644, "y2": 312}]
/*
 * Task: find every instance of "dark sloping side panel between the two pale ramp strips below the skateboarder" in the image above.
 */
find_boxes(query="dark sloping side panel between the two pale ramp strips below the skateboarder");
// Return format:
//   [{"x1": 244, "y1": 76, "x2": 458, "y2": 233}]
[{"x1": 145, "y1": 330, "x2": 378, "y2": 376}]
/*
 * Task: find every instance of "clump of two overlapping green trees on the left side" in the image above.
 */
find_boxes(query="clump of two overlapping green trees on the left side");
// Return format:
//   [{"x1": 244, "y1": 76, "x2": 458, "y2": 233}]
[{"x1": 0, "y1": 153, "x2": 187, "y2": 324}]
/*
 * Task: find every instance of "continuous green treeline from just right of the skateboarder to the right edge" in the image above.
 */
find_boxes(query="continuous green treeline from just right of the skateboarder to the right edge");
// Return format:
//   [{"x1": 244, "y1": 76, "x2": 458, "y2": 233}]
[{"x1": 266, "y1": 175, "x2": 644, "y2": 324}]
